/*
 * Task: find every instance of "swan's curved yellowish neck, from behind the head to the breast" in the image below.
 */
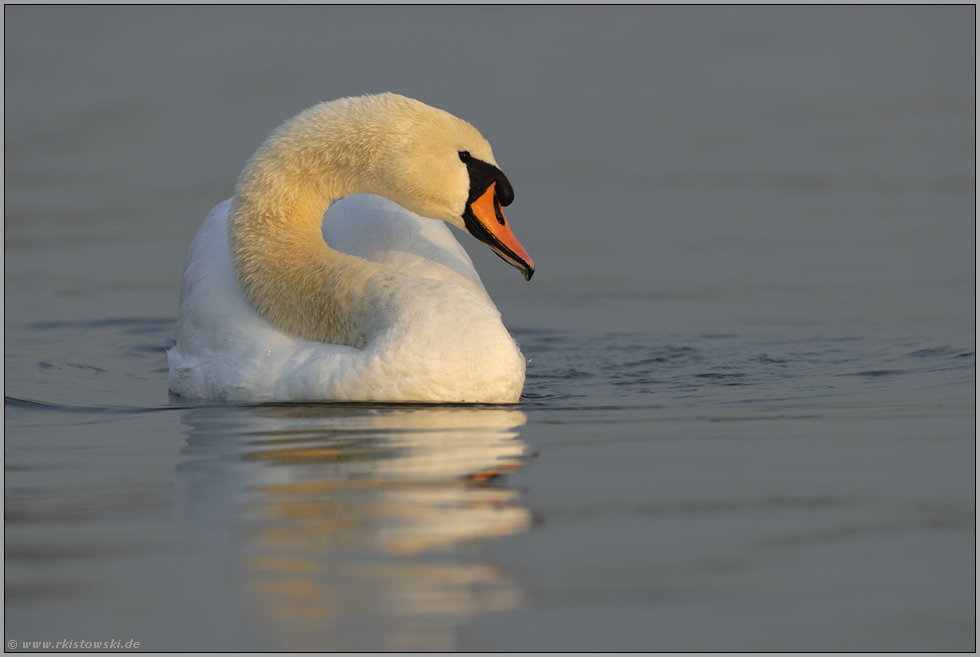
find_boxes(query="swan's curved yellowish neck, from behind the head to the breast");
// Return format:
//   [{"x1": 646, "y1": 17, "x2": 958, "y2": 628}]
[{"x1": 228, "y1": 103, "x2": 391, "y2": 347}]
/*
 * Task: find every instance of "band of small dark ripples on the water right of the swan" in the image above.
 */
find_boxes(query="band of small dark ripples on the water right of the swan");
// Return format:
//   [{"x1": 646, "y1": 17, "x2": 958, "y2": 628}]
[{"x1": 515, "y1": 330, "x2": 975, "y2": 408}]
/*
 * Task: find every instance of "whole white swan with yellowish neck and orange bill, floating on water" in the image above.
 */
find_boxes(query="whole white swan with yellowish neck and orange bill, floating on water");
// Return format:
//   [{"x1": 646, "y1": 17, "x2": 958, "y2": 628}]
[{"x1": 167, "y1": 94, "x2": 534, "y2": 403}]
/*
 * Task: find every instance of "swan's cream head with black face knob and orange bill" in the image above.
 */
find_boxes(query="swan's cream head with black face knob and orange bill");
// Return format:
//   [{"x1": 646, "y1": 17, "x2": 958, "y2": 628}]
[{"x1": 365, "y1": 94, "x2": 534, "y2": 280}]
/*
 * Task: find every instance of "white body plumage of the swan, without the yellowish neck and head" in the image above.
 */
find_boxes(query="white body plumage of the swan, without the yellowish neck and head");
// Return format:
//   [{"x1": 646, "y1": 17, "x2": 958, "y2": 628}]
[{"x1": 168, "y1": 196, "x2": 524, "y2": 403}]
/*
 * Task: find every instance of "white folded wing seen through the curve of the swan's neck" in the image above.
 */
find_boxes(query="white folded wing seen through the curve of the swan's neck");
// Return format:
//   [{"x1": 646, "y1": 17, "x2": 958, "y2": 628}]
[{"x1": 323, "y1": 194, "x2": 493, "y2": 305}]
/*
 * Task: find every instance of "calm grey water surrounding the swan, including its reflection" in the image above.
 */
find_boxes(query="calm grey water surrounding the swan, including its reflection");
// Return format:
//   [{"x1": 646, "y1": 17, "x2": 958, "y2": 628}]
[{"x1": 4, "y1": 6, "x2": 976, "y2": 652}]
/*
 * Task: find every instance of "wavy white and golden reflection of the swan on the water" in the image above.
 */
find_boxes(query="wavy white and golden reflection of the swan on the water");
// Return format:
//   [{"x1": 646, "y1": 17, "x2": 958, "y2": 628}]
[{"x1": 178, "y1": 405, "x2": 531, "y2": 650}]
